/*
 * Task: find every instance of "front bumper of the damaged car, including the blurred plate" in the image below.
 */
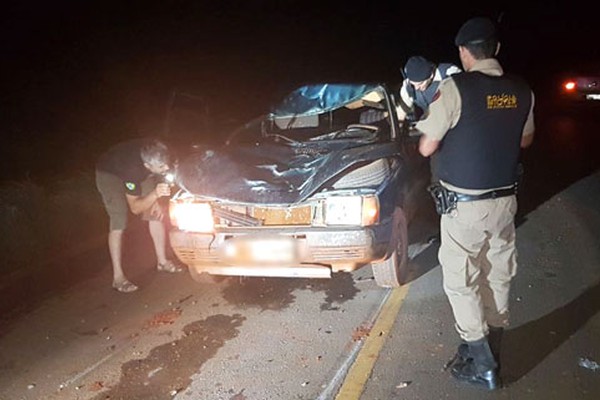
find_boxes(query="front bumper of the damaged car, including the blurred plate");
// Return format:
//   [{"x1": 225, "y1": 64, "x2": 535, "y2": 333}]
[{"x1": 169, "y1": 221, "x2": 392, "y2": 278}]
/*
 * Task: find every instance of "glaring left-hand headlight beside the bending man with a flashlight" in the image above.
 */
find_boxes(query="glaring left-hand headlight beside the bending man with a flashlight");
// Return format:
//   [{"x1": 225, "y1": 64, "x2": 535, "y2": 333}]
[{"x1": 169, "y1": 201, "x2": 215, "y2": 233}]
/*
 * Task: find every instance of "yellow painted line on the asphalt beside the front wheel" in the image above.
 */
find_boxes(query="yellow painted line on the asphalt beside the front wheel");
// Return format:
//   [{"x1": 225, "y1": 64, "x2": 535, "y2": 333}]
[{"x1": 335, "y1": 285, "x2": 409, "y2": 400}]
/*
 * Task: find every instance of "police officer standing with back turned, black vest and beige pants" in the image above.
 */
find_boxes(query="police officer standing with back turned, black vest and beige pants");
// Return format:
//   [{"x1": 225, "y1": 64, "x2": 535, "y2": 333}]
[{"x1": 416, "y1": 17, "x2": 534, "y2": 390}]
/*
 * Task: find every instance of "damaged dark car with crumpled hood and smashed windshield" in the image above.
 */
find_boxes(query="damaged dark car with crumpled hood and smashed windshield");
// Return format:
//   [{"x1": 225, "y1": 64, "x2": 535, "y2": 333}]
[{"x1": 169, "y1": 83, "x2": 429, "y2": 287}]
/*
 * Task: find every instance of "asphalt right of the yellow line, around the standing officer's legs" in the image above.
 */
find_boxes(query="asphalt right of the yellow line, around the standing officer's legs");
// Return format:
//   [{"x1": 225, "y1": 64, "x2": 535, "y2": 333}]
[{"x1": 360, "y1": 172, "x2": 600, "y2": 400}]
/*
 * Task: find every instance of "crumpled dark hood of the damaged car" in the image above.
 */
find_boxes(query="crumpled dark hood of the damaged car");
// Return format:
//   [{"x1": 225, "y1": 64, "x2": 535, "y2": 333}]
[{"x1": 177, "y1": 140, "x2": 399, "y2": 205}]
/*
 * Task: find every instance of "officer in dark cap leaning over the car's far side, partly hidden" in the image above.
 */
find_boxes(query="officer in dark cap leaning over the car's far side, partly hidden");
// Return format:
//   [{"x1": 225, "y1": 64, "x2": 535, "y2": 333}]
[{"x1": 396, "y1": 56, "x2": 461, "y2": 121}]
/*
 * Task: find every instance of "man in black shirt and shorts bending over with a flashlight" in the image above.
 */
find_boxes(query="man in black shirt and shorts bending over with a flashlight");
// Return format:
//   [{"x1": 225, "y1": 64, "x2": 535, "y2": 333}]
[{"x1": 96, "y1": 139, "x2": 182, "y2": 293}]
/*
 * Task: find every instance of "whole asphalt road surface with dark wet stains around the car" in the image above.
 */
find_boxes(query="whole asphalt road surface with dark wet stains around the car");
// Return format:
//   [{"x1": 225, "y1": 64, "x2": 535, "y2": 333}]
[{"x1": 0, "y1": 101, "x2": 600, "y2": 400}]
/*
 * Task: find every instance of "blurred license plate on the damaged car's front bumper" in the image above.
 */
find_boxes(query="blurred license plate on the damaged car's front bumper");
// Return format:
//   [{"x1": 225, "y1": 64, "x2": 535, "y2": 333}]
[{"x1": 225, "y1": 237, "x2": 298, "y2": 264}]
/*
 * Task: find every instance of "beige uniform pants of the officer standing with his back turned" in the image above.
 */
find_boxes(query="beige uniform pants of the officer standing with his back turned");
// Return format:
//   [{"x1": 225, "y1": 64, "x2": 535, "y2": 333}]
[{"x1": 438, "y1": 196, "x2": 517, "y2": 341}]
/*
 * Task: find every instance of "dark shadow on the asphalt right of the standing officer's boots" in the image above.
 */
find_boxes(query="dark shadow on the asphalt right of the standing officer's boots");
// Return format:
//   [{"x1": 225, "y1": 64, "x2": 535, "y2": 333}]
[{"x1": 502, "y1": 283, "x2": 600, "y2": 384}]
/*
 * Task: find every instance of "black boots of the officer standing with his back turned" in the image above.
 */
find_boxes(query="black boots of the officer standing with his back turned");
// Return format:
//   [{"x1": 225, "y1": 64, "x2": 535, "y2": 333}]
[{"x1": 451, "y1": 338, "x2": 500, "y2": 390}]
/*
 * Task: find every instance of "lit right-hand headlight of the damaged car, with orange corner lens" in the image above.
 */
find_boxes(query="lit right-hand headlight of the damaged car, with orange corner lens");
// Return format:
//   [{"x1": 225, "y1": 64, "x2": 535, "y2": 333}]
[{"x1": 325, "y1": 196, "x2": 379, "y2": 226}]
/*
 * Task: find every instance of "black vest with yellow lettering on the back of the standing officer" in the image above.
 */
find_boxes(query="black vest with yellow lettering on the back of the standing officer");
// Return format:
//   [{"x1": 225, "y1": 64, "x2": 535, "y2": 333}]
[{"x1": 433, "y1": 72, "x2": 531, "y2": 189}]
